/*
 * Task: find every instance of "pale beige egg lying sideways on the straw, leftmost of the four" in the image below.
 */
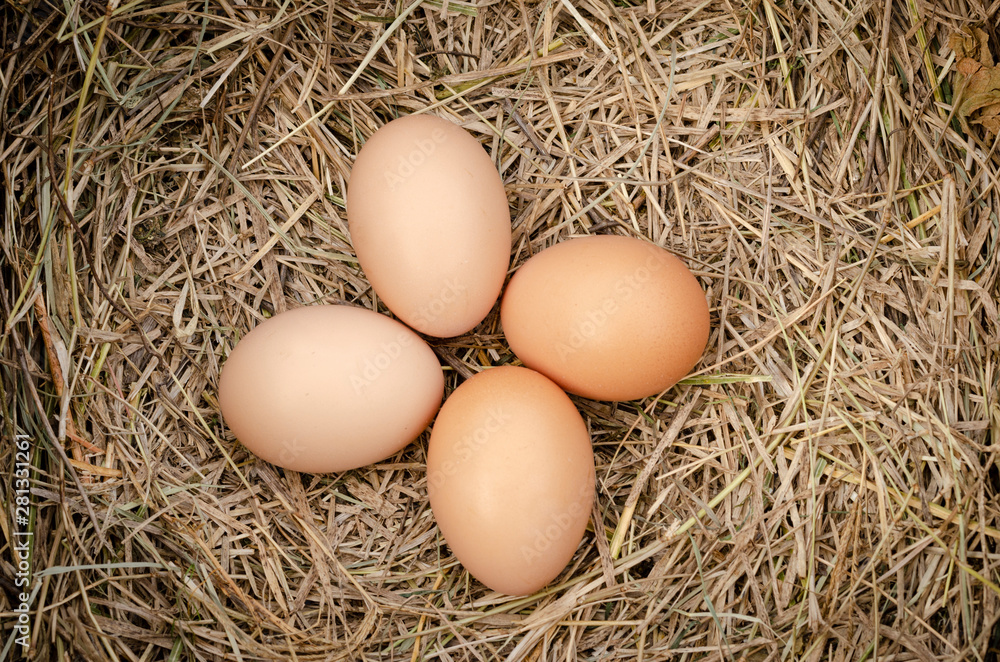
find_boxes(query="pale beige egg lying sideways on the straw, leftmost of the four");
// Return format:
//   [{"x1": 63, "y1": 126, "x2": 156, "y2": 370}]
[{"x1": 219, "y1": 306, "x2": 444, "y2": 473}]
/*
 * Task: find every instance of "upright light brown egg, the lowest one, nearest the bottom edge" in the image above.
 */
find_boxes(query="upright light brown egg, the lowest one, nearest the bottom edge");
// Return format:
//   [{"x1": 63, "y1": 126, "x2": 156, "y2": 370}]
[{"x1": 427, "y1": 366, "x2": 595, "y2": 595}]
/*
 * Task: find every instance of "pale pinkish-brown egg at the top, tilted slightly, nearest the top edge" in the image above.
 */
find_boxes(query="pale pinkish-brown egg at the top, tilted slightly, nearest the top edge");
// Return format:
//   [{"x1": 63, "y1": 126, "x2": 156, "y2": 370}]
[{"x1": 347, "y1": 115, "x2": 511, "y2": 338}]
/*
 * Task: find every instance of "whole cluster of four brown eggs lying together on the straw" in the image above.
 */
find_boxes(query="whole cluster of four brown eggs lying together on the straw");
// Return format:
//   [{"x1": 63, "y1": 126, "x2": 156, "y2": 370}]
[{"x1": 219, "y1": 115, "x2": 709, "y2": 595}]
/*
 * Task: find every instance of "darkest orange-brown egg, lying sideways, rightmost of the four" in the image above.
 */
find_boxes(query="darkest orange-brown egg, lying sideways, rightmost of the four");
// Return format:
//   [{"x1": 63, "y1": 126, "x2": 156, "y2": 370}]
[{"x1": 500, "y1": 235, "x2": 709, "y2": 400}]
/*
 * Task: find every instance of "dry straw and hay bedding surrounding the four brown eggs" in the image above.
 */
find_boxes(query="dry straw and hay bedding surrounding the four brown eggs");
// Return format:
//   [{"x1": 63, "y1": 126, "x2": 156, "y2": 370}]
[{"x1": 0, "y1": 0, "x2": 1000, "y2": 662}]
